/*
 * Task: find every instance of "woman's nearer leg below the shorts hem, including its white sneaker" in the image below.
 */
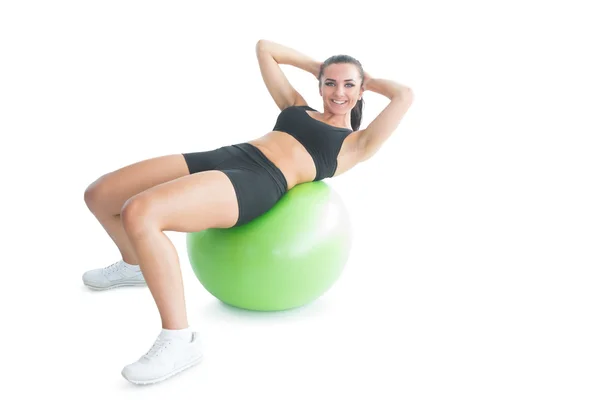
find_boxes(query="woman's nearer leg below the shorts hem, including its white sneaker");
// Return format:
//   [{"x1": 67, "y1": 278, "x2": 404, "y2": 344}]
[{"x1": 121, "y1": 171, "x2": 239, "y2": 384}]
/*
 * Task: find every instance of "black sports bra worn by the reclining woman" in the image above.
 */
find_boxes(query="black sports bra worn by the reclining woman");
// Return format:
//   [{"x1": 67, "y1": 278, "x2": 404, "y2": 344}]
[{"x1": 273, "y1": 106, "x2": 353, "y2": 181}]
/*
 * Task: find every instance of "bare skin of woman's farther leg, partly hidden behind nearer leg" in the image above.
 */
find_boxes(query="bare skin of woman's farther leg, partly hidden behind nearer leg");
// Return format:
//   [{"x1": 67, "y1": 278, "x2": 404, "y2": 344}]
[{"x1": 84, "y1": 154, "x2": 189, "y2": 265}]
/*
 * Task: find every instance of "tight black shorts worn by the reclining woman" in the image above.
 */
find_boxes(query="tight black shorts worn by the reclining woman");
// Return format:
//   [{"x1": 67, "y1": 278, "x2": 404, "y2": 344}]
[{"x1": 183, "y1": 143, "x2": 287, "y2": 226}]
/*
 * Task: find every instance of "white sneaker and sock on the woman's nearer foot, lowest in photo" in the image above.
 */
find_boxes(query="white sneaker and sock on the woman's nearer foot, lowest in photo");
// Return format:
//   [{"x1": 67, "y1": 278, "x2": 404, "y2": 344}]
[{"x1": 121, "y1": 332, "x2": 202, "y2": 385}]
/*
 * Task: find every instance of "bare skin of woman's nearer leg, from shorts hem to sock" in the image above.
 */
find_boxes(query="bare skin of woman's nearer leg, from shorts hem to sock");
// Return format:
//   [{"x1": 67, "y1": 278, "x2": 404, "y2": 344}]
[{"x1": 120, "y1": 171, "x2": 239, "y2": 329}]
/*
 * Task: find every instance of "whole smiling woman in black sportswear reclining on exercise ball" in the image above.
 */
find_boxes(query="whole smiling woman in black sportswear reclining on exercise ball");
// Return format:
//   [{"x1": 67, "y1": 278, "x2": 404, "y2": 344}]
[{"x1": 83, "y1": 40, "x2": 413, "y2": 384}]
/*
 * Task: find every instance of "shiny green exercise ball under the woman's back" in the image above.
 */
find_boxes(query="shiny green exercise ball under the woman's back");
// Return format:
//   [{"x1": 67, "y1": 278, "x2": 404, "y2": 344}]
[{"x1": 187, "y1": 181, "x2": 352, "y2": 311}]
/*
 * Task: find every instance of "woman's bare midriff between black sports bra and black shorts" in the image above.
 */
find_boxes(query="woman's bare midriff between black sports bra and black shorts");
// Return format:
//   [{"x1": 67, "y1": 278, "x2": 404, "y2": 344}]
[{"x1": 248, "y1": 131, "x2": 317, "y2": 190}]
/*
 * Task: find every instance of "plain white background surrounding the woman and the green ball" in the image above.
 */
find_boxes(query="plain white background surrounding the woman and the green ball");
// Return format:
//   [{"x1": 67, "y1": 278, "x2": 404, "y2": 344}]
[{"x1": 0, "y1": 0, "x2": 600, "y2": 400}]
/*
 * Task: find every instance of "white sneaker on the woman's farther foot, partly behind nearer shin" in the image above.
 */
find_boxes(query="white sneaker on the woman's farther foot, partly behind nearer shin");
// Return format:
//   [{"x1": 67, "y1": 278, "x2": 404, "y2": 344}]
[{"x1": 82, "y1": 260, "x2": 146, "y2": 290}]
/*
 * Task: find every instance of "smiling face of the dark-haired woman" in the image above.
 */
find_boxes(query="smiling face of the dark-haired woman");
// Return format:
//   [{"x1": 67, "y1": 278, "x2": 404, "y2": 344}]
[{"x1": 319, "y1": 63, "x2": 364, "y2": 114}]
